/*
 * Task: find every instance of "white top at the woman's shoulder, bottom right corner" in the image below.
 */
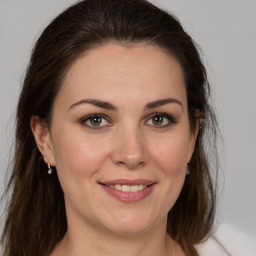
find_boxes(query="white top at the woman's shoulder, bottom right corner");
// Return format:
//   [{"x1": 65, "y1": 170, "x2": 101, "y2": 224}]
[{"x1": 196, "y1": 224, "x2": 256, "y2": 256}]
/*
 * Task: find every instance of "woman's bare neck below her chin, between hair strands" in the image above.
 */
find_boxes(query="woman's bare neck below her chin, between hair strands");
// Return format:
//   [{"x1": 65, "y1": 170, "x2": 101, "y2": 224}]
[{"x1": 51, "y1": 215, "x2": 183, "y2": 256}]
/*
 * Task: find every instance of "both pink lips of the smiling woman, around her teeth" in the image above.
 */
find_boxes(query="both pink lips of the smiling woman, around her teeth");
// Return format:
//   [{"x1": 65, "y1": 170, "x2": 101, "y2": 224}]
[{"x1": 99, "y1": 179, "x2": 156, "y2": 203}]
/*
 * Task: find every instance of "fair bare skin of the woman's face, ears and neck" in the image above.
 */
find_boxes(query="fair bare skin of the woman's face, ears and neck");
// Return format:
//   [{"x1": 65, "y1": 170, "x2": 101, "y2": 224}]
[{"x1": 31, "y1": 43, "x2": 198, "y2": 256}]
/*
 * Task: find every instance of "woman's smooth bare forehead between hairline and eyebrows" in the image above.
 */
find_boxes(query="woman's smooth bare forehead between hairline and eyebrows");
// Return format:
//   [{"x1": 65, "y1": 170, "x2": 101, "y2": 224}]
[{"x1": 57, "y1": 44, "x2": 186, "y2": 108}]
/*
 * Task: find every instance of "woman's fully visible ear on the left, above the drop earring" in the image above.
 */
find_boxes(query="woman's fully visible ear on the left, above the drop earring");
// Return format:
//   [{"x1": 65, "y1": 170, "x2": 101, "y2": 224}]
[{"x1": 30, "y1": 116, "x2": 55, "y2": 166}]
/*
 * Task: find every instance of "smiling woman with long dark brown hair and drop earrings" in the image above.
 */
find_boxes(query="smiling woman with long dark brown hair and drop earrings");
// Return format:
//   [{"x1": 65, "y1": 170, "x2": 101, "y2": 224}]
[{"x1": 2, "y1": 0, "x2": 223, "y2": 256}]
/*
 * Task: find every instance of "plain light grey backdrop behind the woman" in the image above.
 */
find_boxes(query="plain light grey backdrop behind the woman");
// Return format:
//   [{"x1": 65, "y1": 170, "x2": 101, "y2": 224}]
[{"x1": 0, "y1": 0, "x2": 256, "y2": 244}]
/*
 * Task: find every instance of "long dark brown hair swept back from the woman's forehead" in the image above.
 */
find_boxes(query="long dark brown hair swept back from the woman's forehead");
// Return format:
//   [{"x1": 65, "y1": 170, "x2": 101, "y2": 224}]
[{"x1": 1, "y1": 0, "x2": 217, "y2": 256}]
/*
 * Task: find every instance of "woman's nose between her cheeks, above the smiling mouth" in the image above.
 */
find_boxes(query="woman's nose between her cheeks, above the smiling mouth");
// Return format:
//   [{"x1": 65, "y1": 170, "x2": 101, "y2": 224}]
[{"x1": 112, "y1": 126, "x2": 149, "y2": 170}]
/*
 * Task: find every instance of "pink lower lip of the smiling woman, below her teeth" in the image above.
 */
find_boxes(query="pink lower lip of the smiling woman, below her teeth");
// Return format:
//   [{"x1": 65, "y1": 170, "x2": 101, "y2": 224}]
[{"x1": 101, "y1": 184, "x2": 155, "y2": 202}]
